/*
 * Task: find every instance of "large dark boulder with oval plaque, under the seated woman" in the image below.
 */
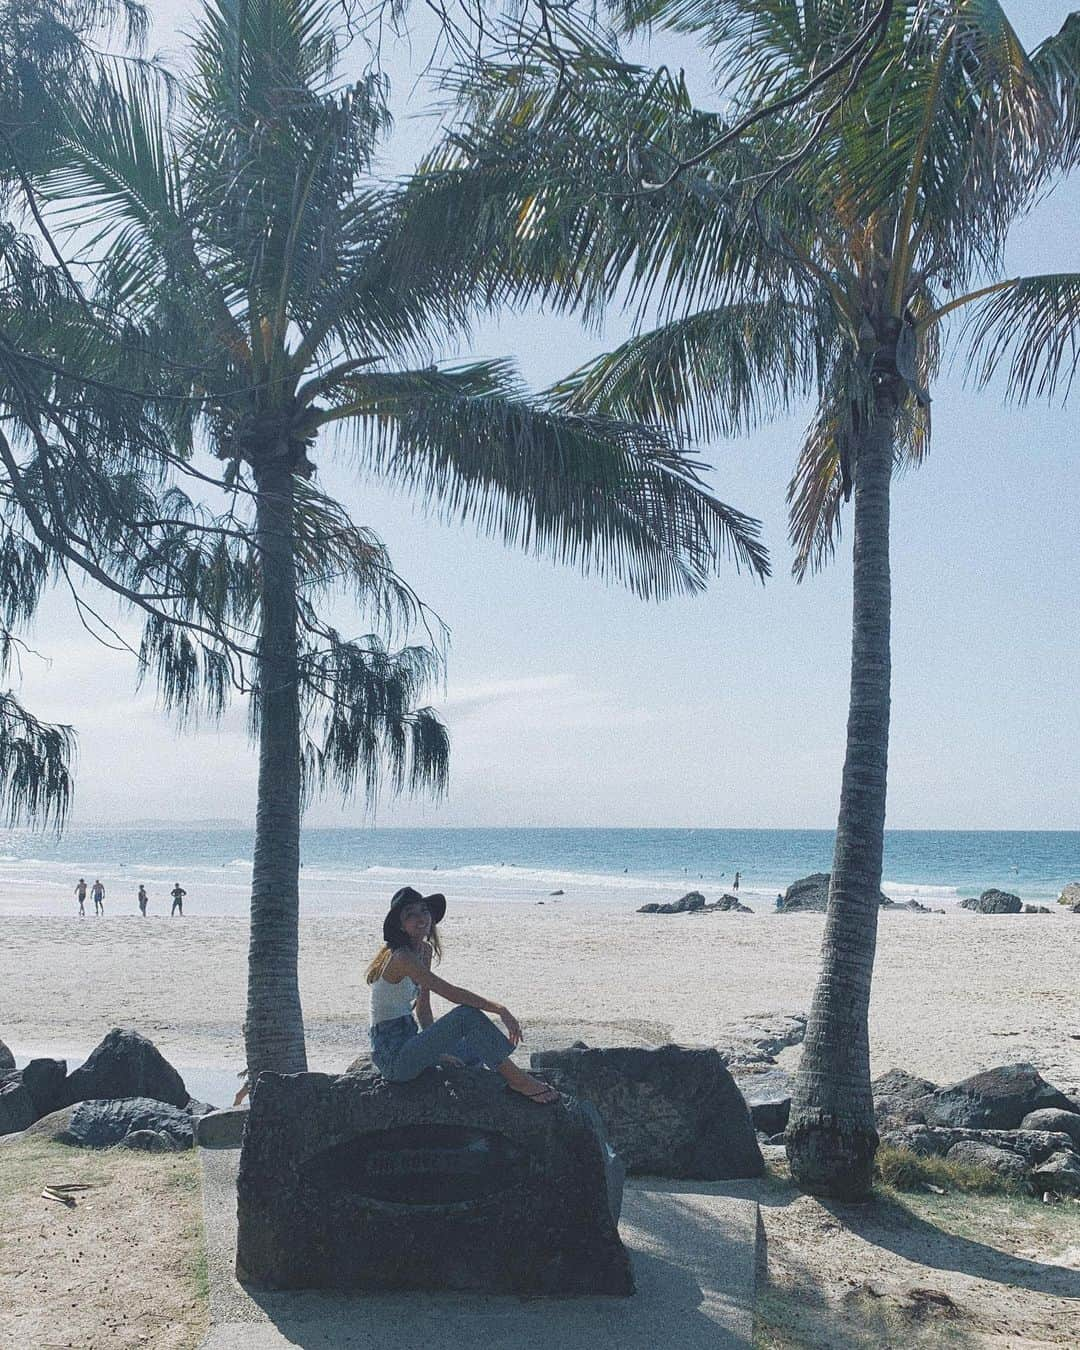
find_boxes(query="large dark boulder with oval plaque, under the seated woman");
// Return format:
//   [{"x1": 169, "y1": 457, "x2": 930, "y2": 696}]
[{"x1": 236, "y1": 1069, "x2": 633, "y2": 1295}]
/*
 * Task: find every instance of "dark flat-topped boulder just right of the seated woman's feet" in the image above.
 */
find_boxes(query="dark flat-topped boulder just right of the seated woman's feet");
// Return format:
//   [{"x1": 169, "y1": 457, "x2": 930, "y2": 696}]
[{"x1": 532, "y1": 1045, "x2": 764, "y2": 1181}]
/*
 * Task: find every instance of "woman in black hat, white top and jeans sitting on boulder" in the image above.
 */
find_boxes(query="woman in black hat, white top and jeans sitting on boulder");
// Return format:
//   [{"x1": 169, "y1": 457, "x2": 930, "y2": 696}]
[{"x1": 367, "y1": 886, "x2": 559, "y2": 1106}]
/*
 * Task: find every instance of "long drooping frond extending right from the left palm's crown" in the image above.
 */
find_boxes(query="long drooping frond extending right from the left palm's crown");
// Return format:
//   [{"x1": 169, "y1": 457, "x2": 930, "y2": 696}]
[{"x1": 318, "y1": 363, "x2": 768, "y2": 597}]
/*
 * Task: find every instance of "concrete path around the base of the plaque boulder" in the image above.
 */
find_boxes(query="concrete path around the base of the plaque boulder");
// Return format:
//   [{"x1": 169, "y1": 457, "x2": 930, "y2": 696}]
[{"x1": 198, "y1": 1149, "x2": 759, "y2": 1350}]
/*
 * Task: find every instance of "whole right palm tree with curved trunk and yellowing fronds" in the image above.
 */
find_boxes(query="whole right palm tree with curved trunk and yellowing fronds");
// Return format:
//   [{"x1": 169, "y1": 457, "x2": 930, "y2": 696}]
[{"x1": 414, "y1": 0, "x2": 1080, "y2": 1199}]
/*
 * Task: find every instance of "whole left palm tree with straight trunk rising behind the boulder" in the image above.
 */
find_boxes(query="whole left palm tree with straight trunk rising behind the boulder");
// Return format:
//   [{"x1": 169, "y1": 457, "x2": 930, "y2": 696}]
[{"x1": 50, "y1": 0, "x2": 767, "y2": 1081}]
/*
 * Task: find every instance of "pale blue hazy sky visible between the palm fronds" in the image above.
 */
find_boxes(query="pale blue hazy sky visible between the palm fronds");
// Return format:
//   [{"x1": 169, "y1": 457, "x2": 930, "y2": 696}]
[{"x1": 12, "y1": 0, "x2": 1080, "y2": 829}]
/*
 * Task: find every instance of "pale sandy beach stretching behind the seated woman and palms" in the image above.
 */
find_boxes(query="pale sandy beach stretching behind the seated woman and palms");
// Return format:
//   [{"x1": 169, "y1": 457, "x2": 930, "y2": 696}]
[{"x1": 0, "y1": 902, "x2": 1080, "y2": 1094}]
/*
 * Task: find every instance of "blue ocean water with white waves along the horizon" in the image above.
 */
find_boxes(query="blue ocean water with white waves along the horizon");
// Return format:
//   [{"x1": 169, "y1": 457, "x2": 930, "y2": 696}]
[{"x1": 0, "y1": 826, "x2": 1080, "y2": 918}]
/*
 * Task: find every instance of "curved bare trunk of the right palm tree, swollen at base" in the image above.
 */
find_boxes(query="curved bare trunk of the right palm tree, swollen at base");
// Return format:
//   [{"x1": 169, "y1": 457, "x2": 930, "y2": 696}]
[{"x1": 787, "y1": 393, "x2": 896, "y2": 1200}]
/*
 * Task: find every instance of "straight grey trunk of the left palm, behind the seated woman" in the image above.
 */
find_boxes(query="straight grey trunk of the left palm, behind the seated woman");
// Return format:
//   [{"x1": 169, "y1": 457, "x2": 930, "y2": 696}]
[{"x1": 244, "y1": 455, "x2": 308, "y2": 1085}]
